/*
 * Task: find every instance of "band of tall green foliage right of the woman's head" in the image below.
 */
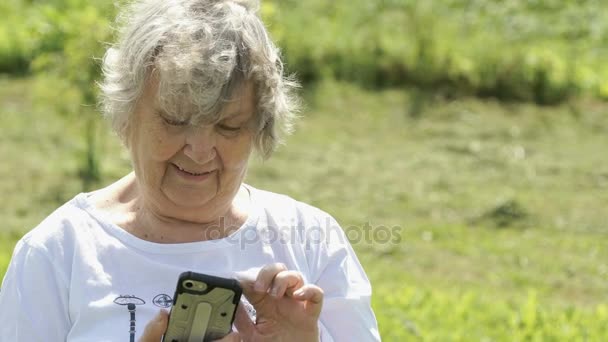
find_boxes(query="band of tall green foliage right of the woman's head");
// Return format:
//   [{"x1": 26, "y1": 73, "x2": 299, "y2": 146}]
[{"x1": 260, "y1": 0, "x2": 608, "y2": 104}]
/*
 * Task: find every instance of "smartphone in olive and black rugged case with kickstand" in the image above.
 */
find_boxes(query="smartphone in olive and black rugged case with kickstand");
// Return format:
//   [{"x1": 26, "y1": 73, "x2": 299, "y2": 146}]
[{"x1": 163, "y1": 272, "x2": 242, "y2": 342}]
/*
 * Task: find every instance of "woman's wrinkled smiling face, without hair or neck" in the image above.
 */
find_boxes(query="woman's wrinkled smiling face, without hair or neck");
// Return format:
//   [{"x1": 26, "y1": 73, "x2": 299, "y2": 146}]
[{"x1": 128, "y1": 77, "x2": 255, "y2": 222}]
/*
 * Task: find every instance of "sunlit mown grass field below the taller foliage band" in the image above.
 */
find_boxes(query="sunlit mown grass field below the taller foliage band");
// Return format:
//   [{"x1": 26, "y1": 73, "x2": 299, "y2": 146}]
[{"x1": 0, "y1": 77, "x2": 608, "y2": 341}]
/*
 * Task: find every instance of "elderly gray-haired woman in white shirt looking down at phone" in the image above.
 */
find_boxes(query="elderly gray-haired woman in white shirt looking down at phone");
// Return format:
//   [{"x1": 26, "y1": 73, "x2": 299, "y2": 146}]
[{"x1": 0, "y1": 0, "x2": 379, "y2": 342}]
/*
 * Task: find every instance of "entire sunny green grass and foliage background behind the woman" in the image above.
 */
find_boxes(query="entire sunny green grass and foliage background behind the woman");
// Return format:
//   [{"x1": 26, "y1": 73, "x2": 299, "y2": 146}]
[{"x1": 0, "y1": 0, "x2": 608, "y2": 341}]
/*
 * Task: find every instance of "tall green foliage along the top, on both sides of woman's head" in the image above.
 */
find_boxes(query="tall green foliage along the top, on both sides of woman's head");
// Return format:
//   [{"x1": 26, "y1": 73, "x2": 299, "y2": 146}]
[{"x1": 0, "y1": 0, "x2": 608, "y2": 104}]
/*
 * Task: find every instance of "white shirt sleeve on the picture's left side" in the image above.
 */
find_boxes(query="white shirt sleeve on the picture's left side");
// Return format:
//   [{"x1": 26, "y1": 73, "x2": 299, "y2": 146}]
[{"x1": 0, "y1": 240, "x2": 70, "y2": 342}]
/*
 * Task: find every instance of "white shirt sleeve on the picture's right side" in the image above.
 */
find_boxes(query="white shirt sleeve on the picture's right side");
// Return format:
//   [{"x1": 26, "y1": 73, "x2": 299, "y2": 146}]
[{"x1": 315, "y1": 219, "x2": 380, "y2": 342}]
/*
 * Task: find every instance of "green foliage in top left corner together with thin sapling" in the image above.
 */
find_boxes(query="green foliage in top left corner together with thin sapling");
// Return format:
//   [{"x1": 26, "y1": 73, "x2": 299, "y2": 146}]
[{"x1": 0, "y1": 0, "x2": 115, "y2": 189}]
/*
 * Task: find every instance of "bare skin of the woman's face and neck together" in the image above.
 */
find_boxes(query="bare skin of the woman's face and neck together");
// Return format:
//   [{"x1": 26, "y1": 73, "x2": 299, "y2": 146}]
[{"x1": 90, "y1": 80, "x2": 255, "y2": 243}]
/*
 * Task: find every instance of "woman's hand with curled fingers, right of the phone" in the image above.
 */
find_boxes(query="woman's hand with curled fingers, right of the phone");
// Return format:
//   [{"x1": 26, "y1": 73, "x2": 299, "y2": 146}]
[{"x1": 234, "y1": 263, "x2": 323, "y2": 342}]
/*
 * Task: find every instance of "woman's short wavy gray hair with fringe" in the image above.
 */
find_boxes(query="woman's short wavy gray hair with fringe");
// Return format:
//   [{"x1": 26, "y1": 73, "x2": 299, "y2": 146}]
[{"x1": 100, "y1": 0, "x2": 299, "y2": 157}]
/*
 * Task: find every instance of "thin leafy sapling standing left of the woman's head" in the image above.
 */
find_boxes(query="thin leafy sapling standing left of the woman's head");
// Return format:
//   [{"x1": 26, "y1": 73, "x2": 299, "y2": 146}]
[{"x1": 32, "y1": 1, "x2": 112, "y2": 190}]
